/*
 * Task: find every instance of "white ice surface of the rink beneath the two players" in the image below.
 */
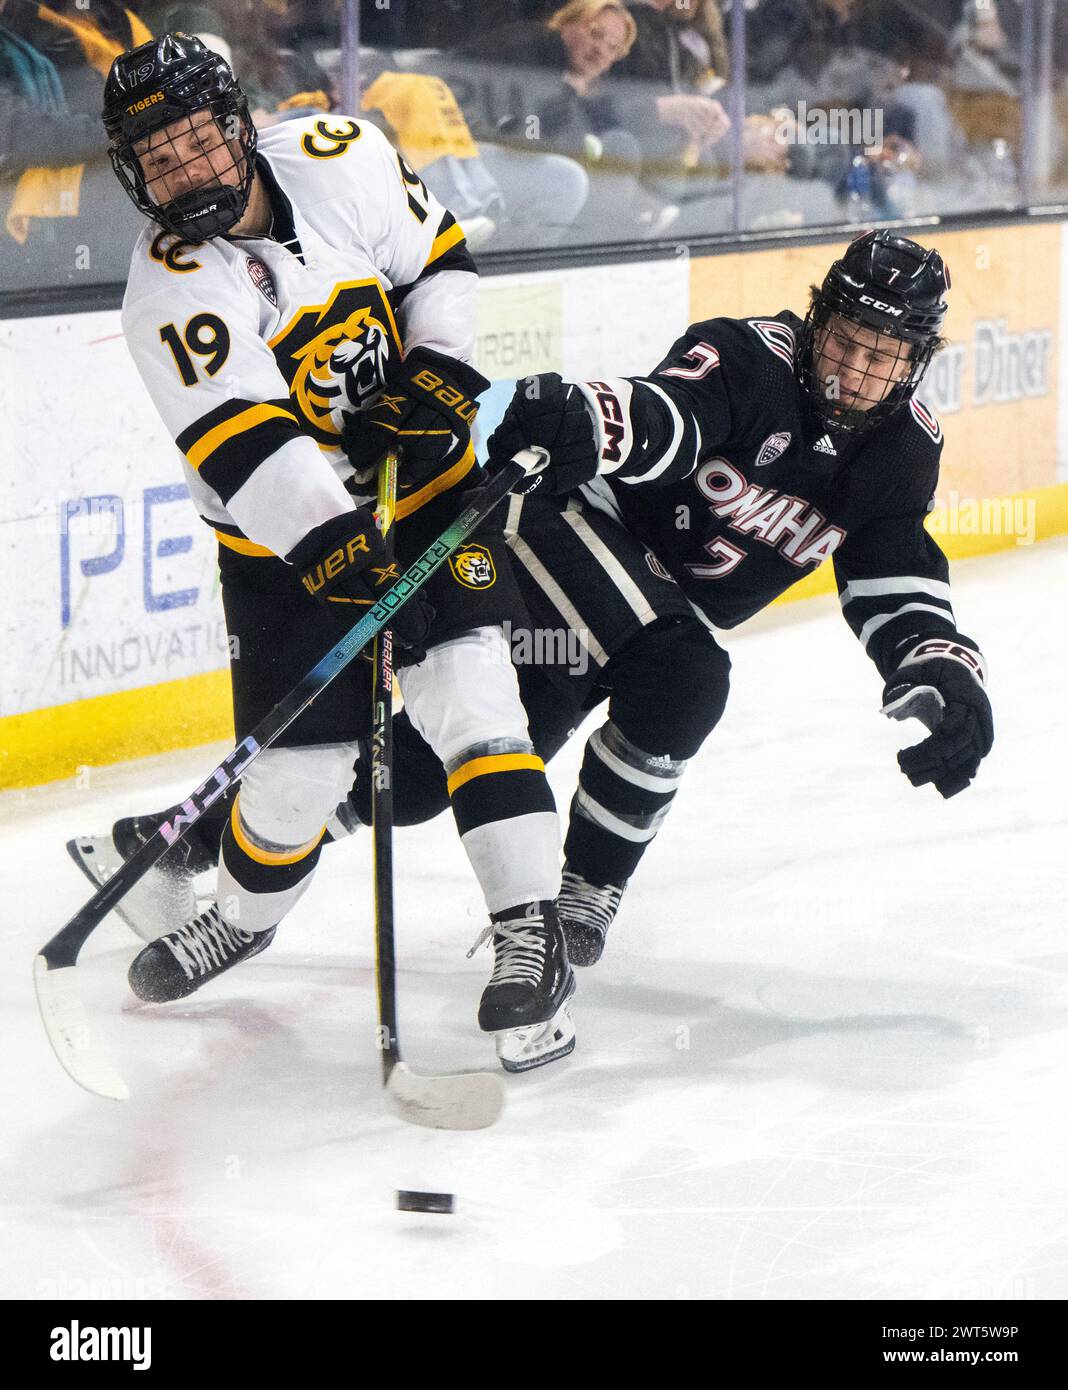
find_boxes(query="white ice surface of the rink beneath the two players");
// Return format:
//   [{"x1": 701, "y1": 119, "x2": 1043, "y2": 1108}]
[{"x1": 0, "y1": 542, "x2": 1068, "y2": 1300}]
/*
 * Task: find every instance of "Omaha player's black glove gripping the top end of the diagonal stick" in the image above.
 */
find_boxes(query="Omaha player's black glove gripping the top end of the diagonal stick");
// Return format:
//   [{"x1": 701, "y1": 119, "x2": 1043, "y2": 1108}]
[{"x1": 488, "y1": 371, "x2": 597, "y2": 493}]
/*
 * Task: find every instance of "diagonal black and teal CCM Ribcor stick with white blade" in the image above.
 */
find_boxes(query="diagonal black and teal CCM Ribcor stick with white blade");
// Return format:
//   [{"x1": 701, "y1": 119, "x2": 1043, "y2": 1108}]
[{"x1": 33, "y1": 449, "x2": 548, "y2": 1101}]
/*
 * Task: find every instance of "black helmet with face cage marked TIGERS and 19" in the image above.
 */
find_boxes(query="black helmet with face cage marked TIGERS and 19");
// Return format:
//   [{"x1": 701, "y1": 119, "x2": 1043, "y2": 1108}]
[{"x1": 103, "y1": 33, "x2": 256, "y2": 242}]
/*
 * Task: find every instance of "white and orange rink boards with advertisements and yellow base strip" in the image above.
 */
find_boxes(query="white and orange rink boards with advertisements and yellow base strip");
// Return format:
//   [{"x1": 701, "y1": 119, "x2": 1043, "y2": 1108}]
[{"x1": 0, "y1": 224, "x2": 1068, "y2": 787}]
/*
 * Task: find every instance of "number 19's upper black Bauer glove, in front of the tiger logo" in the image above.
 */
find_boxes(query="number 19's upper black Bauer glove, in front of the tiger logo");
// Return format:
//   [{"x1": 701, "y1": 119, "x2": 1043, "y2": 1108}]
[{"x1": 342, "y1": 348, "x2": 490, "y2": 493}]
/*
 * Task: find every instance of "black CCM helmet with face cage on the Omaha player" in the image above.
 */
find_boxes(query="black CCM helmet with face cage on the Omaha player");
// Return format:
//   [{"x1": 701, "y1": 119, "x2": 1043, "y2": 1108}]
[{"x1": 797, "y1": 231, "x2": 950, "y2": 434}]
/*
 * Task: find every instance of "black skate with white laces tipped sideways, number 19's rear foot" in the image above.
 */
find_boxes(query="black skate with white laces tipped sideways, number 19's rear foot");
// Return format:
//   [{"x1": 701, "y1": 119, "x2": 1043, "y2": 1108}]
[{"x1": 129, "y1": 905, "x2": 277, "y2": 1004}]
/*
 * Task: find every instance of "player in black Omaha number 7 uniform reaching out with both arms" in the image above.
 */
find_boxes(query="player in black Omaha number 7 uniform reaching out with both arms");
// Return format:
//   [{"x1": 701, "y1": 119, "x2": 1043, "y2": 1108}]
[{"x1": 73, "y1": 232, "x2": 993, "y2": 965}]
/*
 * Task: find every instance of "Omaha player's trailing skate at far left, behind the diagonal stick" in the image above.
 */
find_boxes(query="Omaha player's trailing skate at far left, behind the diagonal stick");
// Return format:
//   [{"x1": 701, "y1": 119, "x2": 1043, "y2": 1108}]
[{"x1": 67, "y1": 812, "x2": 213, "y2": 941}]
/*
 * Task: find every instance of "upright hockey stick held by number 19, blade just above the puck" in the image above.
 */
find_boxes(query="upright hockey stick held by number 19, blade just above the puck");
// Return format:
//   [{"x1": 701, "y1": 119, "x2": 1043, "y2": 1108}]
[{"x1": 371, "y1": 452, "x2": 505, "y2": 1130}]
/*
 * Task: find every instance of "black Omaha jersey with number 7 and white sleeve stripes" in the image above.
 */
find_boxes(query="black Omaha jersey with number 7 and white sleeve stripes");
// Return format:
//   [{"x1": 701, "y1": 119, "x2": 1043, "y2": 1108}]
[{"x1": 579, "y1": 311, "x2": 975, "y2": 676}]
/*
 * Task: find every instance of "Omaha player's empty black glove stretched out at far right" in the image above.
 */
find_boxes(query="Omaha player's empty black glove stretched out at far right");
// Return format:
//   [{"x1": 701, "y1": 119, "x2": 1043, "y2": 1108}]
[{"x1": 883, "y1": 637, "x2": 994, "y2": 796}]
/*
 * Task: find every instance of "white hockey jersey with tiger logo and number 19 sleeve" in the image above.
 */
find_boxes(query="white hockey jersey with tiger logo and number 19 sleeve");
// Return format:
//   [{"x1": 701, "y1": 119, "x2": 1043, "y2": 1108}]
[{"x1": 122, "y1": 117, "x2": 476, "y2": 555}]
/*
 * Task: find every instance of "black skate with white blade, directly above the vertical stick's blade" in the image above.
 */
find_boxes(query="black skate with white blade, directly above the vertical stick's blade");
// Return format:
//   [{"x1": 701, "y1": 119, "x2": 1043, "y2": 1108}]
[{"x1": 469, "y1": 902, "x2": 574, "y2": 1072}]
